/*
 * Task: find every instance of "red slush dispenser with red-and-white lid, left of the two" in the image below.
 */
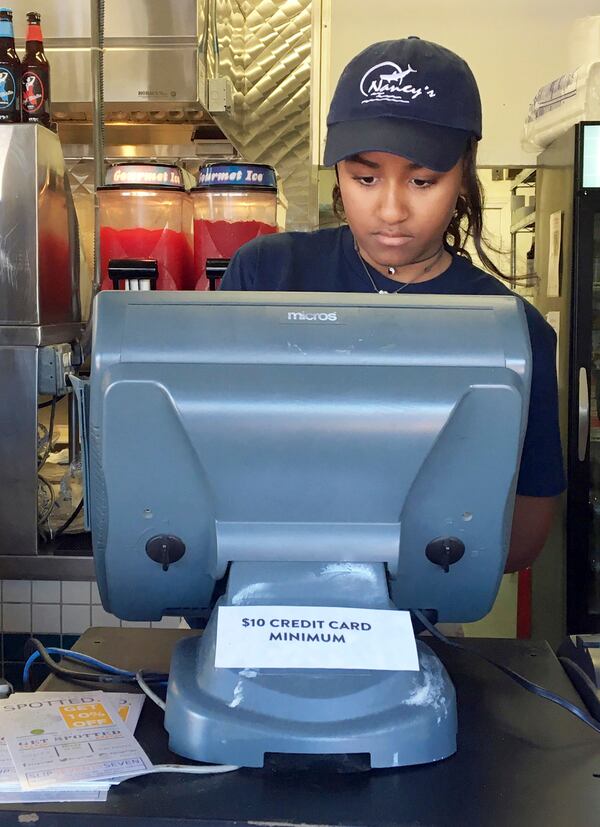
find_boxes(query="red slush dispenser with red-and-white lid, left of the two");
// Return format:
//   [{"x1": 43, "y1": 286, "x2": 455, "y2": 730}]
[{"x1": 98, "y1": 162, "x2": 196, "y2": 290}]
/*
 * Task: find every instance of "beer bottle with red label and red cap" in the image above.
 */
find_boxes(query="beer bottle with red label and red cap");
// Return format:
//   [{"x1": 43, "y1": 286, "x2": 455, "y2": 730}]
[{"x1": 21, "y1": 11, "x2": 50, "y2": 126}]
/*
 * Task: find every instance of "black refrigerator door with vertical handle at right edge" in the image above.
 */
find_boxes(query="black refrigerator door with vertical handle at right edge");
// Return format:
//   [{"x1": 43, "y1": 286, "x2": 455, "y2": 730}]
[{"x1": 567, "y1": 201, "x2": 600, "y2": 634}]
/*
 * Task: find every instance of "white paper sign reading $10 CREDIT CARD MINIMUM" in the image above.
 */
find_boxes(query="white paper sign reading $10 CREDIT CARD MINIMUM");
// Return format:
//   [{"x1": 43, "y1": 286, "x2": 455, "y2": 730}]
[{"x1": 215, "y1": 606, "x2": 419, "y2": 672}]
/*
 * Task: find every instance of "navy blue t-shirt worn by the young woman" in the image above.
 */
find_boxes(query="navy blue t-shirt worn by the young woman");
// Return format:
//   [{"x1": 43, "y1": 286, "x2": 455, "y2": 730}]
[{"x1": 221, "y1": 226, "x2": 565, "y2": 497}]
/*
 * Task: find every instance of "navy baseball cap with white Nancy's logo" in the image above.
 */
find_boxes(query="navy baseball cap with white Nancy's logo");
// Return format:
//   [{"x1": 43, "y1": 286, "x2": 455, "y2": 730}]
[{"x1": 324, "y1": 37, "x2": 481, "y2": 172}]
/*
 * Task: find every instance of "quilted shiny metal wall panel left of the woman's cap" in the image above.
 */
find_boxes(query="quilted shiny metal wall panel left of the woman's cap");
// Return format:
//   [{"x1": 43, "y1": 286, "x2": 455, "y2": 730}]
[{"x1": 204, "y1": 0, "x2": 315, "y2": 229}]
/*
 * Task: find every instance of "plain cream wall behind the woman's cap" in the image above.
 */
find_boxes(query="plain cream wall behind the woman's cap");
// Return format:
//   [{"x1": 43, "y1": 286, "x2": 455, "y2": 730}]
[{"x1": 321, "y1": 0, "x2": 600, "y2": 166}]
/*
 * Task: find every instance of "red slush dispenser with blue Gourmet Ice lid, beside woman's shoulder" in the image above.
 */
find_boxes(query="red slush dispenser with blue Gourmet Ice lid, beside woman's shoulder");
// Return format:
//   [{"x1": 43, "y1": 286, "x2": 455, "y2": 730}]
[{"x1": 191, "y1": 163, "x2": 277, "y2": 290}]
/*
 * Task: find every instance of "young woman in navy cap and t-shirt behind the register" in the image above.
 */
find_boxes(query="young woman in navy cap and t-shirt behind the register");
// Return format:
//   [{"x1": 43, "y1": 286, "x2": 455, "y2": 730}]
[{"x1": 221, "y1": 37, "x2": 565, "y2": 571}]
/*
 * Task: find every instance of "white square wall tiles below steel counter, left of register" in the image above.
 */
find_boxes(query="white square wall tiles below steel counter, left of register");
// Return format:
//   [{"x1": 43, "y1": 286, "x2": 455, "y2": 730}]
[{"x1": 0, "y1": 580, "x2": 180, "y2": 635}]
